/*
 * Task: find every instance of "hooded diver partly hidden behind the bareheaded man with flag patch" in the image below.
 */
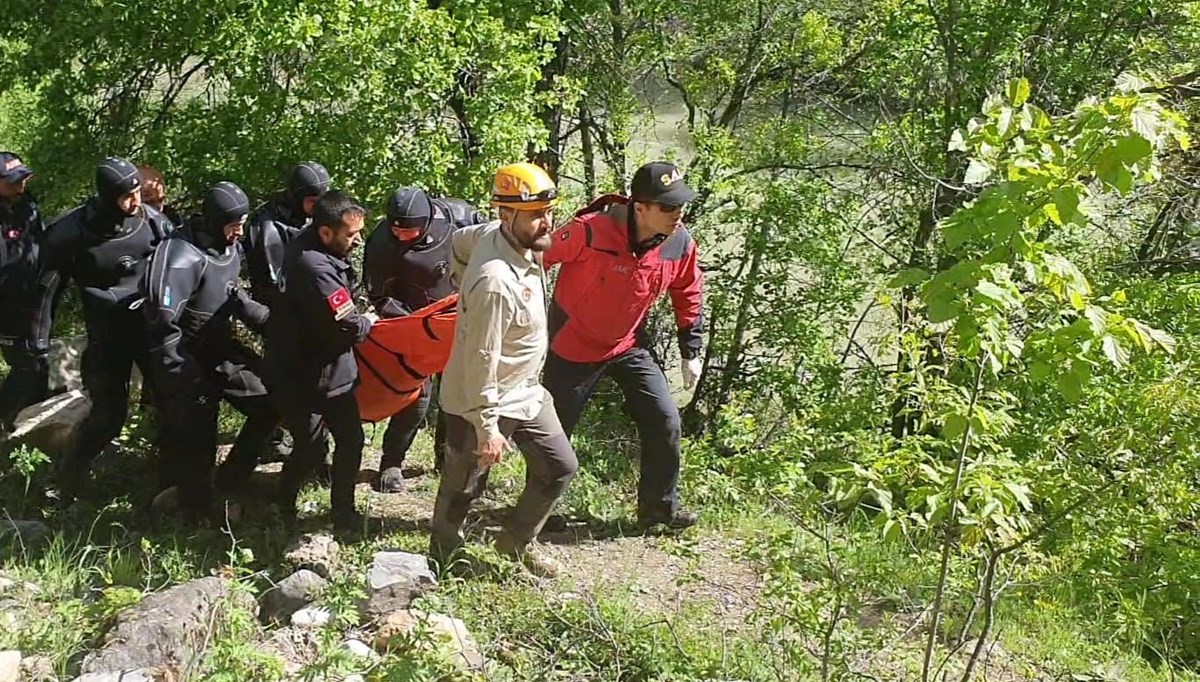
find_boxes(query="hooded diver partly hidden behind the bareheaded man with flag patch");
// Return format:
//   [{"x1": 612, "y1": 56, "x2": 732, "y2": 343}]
[{"x1": 242, "y1": 161, "x2": 330, "y2": 463}]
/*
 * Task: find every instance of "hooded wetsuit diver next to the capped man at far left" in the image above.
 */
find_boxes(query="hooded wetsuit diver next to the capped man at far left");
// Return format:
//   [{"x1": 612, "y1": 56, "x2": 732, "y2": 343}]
[{"x1": 37, "y1": 157, "x2": 170, "y2": 497}]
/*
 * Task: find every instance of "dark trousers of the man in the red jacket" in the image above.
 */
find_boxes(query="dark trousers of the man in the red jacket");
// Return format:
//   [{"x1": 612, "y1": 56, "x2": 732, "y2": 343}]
[{"x1": 545, "y1": 348, "x2": 682, "y2": 518}]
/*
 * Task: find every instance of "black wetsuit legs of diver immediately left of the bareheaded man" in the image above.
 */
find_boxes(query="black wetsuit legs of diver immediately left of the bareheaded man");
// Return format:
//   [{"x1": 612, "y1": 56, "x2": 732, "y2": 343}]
[{"x1": 155, "y1": 375, "x2": 280, "y2": 514}]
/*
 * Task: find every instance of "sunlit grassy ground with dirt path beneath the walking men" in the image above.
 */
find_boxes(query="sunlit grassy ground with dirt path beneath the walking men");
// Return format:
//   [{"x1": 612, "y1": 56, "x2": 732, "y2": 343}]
[{"x1": 0, "y1": 393, "x2": 1198, "y2": 682}]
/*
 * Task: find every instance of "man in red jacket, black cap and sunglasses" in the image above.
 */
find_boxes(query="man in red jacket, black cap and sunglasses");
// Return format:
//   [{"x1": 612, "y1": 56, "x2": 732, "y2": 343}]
[{"x1": 545, "y1": 162, "x2": 703, "y2": 528}]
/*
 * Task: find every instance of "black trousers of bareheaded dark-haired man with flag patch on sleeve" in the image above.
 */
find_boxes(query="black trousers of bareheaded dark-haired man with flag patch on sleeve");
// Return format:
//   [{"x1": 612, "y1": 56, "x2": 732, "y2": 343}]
[{"x1": 280, "y1": 390, "x2": 365, "y2": 522}]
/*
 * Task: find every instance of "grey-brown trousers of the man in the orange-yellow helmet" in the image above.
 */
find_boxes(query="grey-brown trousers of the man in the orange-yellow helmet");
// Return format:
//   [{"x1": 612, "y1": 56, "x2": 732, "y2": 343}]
[{"x1": 431, "y1": 393, "x2": 580, "y2": 550}]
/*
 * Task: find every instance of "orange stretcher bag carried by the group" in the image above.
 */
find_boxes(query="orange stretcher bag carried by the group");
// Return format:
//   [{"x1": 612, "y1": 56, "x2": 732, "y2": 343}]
[{"x1": 354, "y1": 294, "x2": 458, "y2": 421}]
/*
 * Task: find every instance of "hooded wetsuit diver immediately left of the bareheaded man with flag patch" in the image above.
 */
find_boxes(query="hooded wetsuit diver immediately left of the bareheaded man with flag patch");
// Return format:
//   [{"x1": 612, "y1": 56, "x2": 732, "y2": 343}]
[{"x1": 142, "y1": 183, "x2": 280, "y2": 520}]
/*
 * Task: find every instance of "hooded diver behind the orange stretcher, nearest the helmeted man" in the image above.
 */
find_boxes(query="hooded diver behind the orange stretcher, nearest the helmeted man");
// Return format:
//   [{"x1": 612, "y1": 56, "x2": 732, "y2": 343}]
[{"x1": 362, "y1": 187, "x2": 487, "y2": 492}]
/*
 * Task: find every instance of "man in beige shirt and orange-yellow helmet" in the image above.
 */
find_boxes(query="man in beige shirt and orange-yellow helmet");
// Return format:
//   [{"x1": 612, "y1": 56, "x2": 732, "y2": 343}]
[{"x1": 430, "y1": 163, "x2": 578, "y2": 576}]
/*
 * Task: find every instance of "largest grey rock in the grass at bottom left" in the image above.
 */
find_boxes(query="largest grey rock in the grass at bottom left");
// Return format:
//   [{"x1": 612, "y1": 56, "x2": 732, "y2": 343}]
[{"x1": 82, "y1": 576, "x2": 248, "y2": 672}]
